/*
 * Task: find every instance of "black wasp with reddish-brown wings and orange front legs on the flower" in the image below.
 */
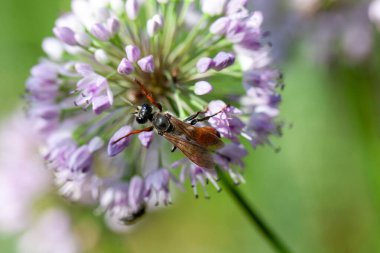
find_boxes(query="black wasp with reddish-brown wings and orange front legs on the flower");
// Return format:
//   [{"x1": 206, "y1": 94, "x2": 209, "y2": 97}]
[{"x1": 113, "y1": 79, "x2": 224, "y2": 169}]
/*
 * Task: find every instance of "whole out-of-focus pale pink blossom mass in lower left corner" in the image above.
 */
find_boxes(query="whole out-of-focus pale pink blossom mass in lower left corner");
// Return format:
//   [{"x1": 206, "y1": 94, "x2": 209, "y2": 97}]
[{"x1": 0, "y1": 112, "x2": 81, "y2": 253}]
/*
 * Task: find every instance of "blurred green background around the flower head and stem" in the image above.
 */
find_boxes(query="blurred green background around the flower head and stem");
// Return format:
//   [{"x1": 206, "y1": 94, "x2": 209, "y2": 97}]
[{"x1": 0, "y1": 0, "x2": 380, "y2": 253}]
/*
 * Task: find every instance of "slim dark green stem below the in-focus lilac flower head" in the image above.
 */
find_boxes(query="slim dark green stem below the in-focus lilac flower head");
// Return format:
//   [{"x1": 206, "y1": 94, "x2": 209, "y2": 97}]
[{"x1": 218, "y1": 168, "x2": 291, "y2": 253}]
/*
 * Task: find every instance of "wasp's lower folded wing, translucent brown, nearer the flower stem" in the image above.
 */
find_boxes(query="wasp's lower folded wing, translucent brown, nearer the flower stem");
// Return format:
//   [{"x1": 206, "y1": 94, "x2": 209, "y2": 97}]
[{"x1": 163, "y1": 132, "x2": 214, "y2": 169}]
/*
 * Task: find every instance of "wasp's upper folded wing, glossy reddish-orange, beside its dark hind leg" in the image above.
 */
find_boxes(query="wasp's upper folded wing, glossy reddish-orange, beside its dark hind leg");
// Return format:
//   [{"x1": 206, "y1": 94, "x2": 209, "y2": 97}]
[{"x1": 169, "y1": 116, "x2": 224, "y2": 151}]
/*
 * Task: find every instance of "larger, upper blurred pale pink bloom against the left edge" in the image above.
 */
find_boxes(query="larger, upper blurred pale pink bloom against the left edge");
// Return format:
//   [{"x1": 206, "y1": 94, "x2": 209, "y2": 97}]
[{"x1": 0, "y1": 112, "x2": 51, "y2": 235}]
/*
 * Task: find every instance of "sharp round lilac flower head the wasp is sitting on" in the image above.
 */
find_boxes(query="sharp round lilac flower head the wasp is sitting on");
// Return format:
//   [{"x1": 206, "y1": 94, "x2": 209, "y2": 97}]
[{"x1": 27, "y1": 0, "x2": 282, "y2": 223}]
